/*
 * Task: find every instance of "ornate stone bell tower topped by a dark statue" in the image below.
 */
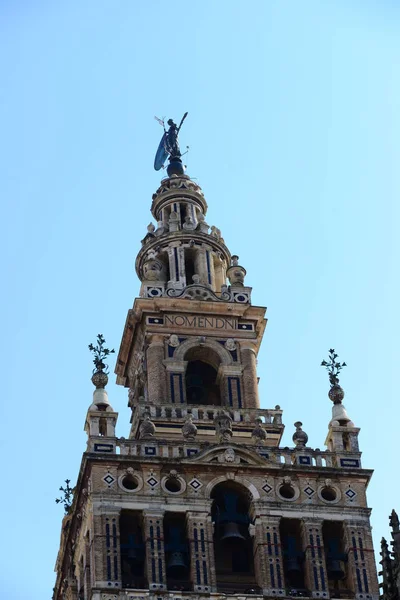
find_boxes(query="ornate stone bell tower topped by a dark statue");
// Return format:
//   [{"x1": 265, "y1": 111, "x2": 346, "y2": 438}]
[{"x1": 53, "y1": 120, "x2": 378, "y2": 600}]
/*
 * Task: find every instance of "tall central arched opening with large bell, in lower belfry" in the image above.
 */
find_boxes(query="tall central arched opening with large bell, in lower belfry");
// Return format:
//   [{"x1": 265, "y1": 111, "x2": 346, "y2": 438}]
[{"x1": 211, "y1": 482, "x2": 257, "y2": 594}]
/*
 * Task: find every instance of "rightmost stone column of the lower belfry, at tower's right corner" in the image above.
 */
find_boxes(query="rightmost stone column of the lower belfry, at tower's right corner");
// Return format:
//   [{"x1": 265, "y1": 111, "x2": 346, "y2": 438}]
[{"x1": 344, "y1": 522, "x2": 379, "y2": 600}]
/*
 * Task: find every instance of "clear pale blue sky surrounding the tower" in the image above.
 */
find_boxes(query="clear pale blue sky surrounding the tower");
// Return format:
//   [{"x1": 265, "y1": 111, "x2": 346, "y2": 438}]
[{"x1": 0, "y1": 0, "x2": 400, "y2": 600}]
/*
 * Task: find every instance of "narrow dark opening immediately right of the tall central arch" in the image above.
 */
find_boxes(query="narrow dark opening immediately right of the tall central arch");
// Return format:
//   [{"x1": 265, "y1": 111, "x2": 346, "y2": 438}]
[{"x1": 280, "y1": 519, "x2": 308, "y2": 596}]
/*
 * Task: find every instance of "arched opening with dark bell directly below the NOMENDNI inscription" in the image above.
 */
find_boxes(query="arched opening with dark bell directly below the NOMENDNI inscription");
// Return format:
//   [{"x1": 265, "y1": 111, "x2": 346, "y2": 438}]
[{"x1": 185, "y1": 346, "x2": 221, "y2": 406}]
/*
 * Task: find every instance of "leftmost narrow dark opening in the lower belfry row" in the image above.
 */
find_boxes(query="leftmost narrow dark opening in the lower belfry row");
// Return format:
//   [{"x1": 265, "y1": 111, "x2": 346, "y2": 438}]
[{"x1": 119, "y1": 510, "x2": 148, "y2": 589}]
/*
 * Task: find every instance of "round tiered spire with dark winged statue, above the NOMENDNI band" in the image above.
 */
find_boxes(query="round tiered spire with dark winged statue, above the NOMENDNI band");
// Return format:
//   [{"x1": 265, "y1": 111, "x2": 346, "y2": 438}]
[{"x1": 136, "y1": 119, "x2": 251, "y2": 304}]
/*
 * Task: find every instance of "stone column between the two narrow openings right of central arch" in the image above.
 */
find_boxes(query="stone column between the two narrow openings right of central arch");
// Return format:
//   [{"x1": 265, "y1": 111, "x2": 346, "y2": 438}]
[{"x1": 301, "y1": 519, "x2": 329, "y2": 598}]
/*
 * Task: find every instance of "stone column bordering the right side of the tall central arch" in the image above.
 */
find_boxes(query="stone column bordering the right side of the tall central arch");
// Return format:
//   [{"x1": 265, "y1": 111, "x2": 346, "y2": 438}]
[{"x1": 253, "y1": 515, "x2": 285, "y2": 596}]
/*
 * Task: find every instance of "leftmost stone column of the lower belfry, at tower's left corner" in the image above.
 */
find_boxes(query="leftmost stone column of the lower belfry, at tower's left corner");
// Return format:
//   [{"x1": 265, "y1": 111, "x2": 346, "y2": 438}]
[{"x1": 92, "y1": 510, "x2": 121, "y2": 589}]
